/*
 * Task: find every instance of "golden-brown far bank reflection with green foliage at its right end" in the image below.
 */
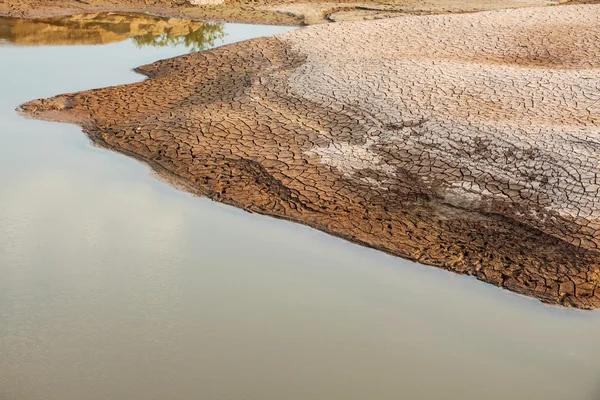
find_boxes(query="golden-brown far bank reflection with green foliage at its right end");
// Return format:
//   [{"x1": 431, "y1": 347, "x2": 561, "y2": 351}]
[{"x1": 0, "y1": 13, "x2": 225, "y2": 51}]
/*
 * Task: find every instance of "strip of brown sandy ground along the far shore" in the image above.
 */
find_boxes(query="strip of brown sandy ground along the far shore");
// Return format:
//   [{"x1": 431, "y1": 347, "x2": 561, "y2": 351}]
[{"x1": 0, "y1": 0, "x2": 584, "y2": 25}]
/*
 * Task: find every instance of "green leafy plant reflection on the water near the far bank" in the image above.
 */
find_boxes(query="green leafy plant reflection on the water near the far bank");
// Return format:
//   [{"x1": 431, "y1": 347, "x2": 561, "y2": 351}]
[{"x1": 132, "y1": 23, "x2": 225, "y2": 51}]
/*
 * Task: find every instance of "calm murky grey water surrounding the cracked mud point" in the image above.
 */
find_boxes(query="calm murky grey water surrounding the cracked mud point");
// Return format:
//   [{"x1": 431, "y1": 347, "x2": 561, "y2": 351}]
[{"x1": 0, "y1": 15, "x2": 600, "y2": 400}]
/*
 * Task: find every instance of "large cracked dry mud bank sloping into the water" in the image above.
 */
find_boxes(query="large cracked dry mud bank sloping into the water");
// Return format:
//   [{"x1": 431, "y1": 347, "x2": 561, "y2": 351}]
[{"x1": 22, "y1": 5, "x2": 600, "y2": 309}]
